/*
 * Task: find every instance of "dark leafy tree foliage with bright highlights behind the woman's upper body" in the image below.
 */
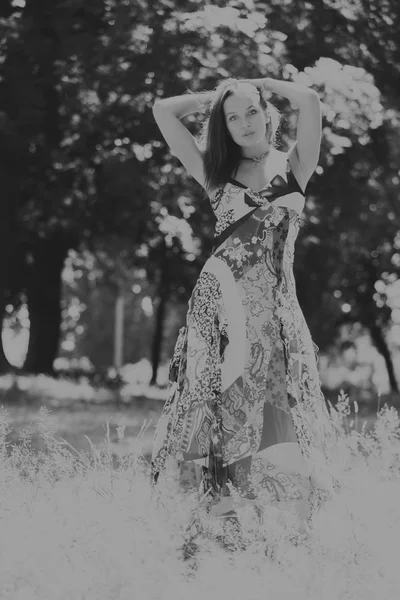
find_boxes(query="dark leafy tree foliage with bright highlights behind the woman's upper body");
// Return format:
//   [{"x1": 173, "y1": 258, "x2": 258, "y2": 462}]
[{"x1": 0, "y1": 0, "x2": 400, "y2": 385}]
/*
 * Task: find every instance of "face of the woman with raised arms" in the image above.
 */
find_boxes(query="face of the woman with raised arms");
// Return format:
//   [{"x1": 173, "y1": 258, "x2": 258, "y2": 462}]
[{"x1": 223, "y1": 86, "x2": 266, "y2": 146}]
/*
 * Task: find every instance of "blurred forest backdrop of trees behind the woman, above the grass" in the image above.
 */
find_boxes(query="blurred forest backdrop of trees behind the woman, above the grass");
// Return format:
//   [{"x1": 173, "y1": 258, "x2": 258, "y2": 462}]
[{"x1": 0, "y1": 0, "x2": 400, "y2": 436}]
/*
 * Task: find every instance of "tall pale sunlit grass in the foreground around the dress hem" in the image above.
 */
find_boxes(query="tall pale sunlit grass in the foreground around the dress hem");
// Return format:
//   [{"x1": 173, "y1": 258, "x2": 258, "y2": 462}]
[{"x1": 0, "y1": 395, "x2": 400, "y2": 600}]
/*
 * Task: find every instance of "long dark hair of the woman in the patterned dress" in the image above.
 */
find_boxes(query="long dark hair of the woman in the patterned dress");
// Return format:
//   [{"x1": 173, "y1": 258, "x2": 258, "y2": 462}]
[{"x1": 190, "y1": 78, "x2": 282, "y2": 197}]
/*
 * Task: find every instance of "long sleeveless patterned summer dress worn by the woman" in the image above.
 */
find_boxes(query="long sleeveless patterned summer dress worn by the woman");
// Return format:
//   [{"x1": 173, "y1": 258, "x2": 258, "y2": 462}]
[{"x1": 151, "y1": 153, "x2": 335, "y2": 523}]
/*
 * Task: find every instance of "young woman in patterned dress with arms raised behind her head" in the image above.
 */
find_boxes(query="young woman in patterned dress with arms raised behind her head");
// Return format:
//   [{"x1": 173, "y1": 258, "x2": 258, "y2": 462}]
[{"x1": 152, "y1": 78, "x2": 340, "y2": 544}]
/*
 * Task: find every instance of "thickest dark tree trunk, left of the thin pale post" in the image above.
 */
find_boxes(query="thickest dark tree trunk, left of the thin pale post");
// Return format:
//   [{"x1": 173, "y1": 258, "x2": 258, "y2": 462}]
[{"x1": 23, "y1": 234, "x2": 68, "y2": 375}]
